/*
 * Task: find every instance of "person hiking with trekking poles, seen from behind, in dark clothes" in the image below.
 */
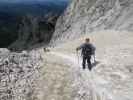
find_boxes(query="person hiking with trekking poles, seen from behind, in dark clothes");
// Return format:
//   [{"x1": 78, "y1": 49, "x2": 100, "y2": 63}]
[{"x1": 76, "y1": 38, "x2": 96, "y2": 71}]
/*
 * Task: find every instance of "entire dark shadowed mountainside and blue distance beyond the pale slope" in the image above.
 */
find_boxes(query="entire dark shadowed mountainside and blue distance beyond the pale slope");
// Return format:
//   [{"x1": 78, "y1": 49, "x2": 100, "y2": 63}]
[{"x1": 0, "y1": 0, "x2": 68, "y2": 49}]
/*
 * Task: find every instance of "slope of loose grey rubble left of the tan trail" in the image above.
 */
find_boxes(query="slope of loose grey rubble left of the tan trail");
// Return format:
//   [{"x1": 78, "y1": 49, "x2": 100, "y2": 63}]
[{"x1": 0, "y1": 49, "x2": 43, "y2": 100}]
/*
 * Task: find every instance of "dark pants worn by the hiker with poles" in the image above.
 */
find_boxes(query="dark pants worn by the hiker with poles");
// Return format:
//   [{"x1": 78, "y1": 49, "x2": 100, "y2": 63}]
[{"x1": 82, "y1": 56, "x2": 92, "y2": 70}]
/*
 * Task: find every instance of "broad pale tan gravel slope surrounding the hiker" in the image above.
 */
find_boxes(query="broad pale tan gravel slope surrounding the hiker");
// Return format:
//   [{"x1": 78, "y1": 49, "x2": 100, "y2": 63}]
[{"x1": 41, "y1": 31, "x2": 133, "y2": 100}]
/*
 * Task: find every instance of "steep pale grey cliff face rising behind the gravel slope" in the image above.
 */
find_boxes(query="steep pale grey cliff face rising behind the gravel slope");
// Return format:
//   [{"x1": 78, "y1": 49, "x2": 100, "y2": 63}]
[{"x1": 52, "y1": 0, "x2": 133, "y2": 43}]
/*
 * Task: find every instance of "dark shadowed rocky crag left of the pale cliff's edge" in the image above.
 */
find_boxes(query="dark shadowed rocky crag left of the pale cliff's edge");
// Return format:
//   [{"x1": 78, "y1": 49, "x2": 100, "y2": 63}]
[{"x1": 8, "y1": 13, "x2": 59, "y2": 51}]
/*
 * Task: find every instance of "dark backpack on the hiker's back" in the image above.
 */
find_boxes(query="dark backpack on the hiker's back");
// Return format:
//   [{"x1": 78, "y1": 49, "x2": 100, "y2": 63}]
[{"x1": 82, "y1": 44, "x2": 92, "y2": 56}]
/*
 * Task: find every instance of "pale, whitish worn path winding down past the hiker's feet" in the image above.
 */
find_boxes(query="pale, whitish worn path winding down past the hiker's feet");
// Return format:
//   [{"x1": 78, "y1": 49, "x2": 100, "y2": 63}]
[{"x1": 50, "y1": 52, "x2": 114, "y2": 100}]
